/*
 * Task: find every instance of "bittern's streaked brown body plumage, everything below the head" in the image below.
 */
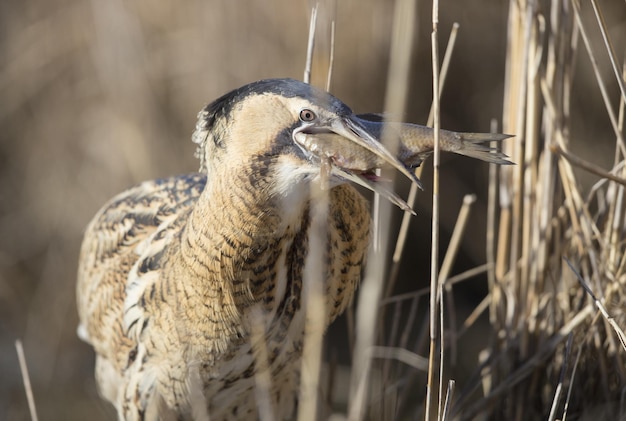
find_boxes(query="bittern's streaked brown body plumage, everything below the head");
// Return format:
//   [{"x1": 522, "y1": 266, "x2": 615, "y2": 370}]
[{"x1": 78, "y1": 166, "x2": 369, "y2": 420}]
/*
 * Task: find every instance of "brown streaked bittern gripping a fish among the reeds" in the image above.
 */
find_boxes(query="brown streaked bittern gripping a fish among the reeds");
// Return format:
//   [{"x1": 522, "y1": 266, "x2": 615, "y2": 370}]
[{"x1": 77, "y1": 79, "x2": 508, "y2": 420}]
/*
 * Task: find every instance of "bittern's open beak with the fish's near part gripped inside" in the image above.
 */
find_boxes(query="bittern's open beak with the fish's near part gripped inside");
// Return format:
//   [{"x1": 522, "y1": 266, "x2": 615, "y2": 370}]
[{"x1": 293, "y1": 116, "x2": 421, "y2": 214}]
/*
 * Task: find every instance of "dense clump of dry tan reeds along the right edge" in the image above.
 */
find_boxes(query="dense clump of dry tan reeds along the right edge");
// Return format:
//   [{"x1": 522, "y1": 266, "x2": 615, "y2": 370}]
[{"x1": 446, "y1": 0, "x2": 626, "y2": 419}]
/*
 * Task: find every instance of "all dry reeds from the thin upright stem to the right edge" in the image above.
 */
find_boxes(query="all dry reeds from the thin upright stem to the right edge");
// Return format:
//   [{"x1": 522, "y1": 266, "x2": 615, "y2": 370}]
[{"x1": 334, "y1": 1, "x2": 626, "y2": 420}]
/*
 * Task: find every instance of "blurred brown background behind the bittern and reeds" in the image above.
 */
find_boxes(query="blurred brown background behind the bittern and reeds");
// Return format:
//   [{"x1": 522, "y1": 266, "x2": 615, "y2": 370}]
[{"x1": 0, "y1": 0, "x2": 626, "y2": 420}]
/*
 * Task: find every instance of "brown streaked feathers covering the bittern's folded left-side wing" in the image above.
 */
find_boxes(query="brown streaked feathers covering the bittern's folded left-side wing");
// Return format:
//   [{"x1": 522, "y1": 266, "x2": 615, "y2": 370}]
[{"x1": 77, "y1": 174, "x2": 206, "y2": 346}]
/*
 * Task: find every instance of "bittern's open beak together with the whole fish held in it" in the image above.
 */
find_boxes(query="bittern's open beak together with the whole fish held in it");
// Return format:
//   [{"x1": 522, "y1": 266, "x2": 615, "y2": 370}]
[{"x1": 293, "y1": 115, "x2": 511, "y2": 214}]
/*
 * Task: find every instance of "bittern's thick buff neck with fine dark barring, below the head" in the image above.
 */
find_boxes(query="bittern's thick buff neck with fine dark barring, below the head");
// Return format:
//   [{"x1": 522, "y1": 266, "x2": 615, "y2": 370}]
[{"x1": 171, "y1": 170, "x2": 309, "y2": 347}]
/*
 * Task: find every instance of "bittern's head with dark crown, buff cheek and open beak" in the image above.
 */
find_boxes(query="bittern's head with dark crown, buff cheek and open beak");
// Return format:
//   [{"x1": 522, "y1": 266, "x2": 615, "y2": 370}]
[{"x1": 193, "y1": 79, "x2": 416, "y2": 210}]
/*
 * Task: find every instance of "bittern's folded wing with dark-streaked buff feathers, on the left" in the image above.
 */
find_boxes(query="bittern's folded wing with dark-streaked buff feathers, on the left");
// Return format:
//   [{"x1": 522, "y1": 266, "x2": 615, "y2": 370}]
[{"x1": 77, "y1": 174, "x2": 206, "y2": 364}]
